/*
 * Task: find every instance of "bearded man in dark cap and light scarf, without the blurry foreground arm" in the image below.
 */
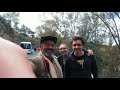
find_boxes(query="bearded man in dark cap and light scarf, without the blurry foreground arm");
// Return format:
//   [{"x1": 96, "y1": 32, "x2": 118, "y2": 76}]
[{"x1": 30, "y1": 36, "x2": 63, "y2": 78}]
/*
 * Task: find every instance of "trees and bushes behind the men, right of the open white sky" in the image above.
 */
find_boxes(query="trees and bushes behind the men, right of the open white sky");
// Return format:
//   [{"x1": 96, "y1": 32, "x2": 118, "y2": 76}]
[{"x1": 37, "y1": 12, "x2": 120, "y2": 77}]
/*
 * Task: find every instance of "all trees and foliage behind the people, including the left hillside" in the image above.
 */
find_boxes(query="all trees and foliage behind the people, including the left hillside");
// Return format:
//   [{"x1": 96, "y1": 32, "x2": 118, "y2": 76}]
[{"x1": 0, "y1": 12, "x2": 120, "y2": 78}]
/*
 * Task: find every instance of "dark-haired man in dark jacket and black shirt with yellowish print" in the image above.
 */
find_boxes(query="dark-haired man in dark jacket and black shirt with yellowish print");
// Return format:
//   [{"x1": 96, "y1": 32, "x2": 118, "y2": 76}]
[{"x1": 65, "y1": 36, "x2": 98, "y2": 78}]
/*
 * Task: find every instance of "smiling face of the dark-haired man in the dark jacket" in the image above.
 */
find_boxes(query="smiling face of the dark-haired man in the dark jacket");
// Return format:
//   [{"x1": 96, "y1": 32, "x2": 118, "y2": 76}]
[{"x1": 72, "y1": 40, "x2": 83, "y2": 53}]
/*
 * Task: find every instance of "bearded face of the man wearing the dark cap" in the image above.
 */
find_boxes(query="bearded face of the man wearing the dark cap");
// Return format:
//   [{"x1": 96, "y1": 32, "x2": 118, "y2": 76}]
[{"x1": 41, "y1": 40, "x2": 55, "y2": 57}]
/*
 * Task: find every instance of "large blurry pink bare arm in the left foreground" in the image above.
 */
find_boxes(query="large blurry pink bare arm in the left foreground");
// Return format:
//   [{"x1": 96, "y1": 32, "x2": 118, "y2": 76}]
[{"x1": 0, "y1": 37, "x2": 36, "y2": 78}]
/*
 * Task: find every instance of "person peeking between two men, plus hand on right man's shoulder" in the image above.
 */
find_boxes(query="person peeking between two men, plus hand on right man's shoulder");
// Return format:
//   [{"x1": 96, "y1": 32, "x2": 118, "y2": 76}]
[{"x1": 58, "y1": 43, "x2": 93, "y2": 77}]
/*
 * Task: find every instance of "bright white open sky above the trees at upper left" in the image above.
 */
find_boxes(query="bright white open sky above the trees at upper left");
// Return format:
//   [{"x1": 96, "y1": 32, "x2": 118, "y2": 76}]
[{"x1": 0, "y1": 12, "x2": 50, "y2": 31}]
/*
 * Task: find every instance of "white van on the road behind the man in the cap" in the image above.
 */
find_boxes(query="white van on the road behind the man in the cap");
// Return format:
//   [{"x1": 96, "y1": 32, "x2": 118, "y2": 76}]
[{"x1": 20, "y1": 42, "x2": 32, "y2": 53}]
